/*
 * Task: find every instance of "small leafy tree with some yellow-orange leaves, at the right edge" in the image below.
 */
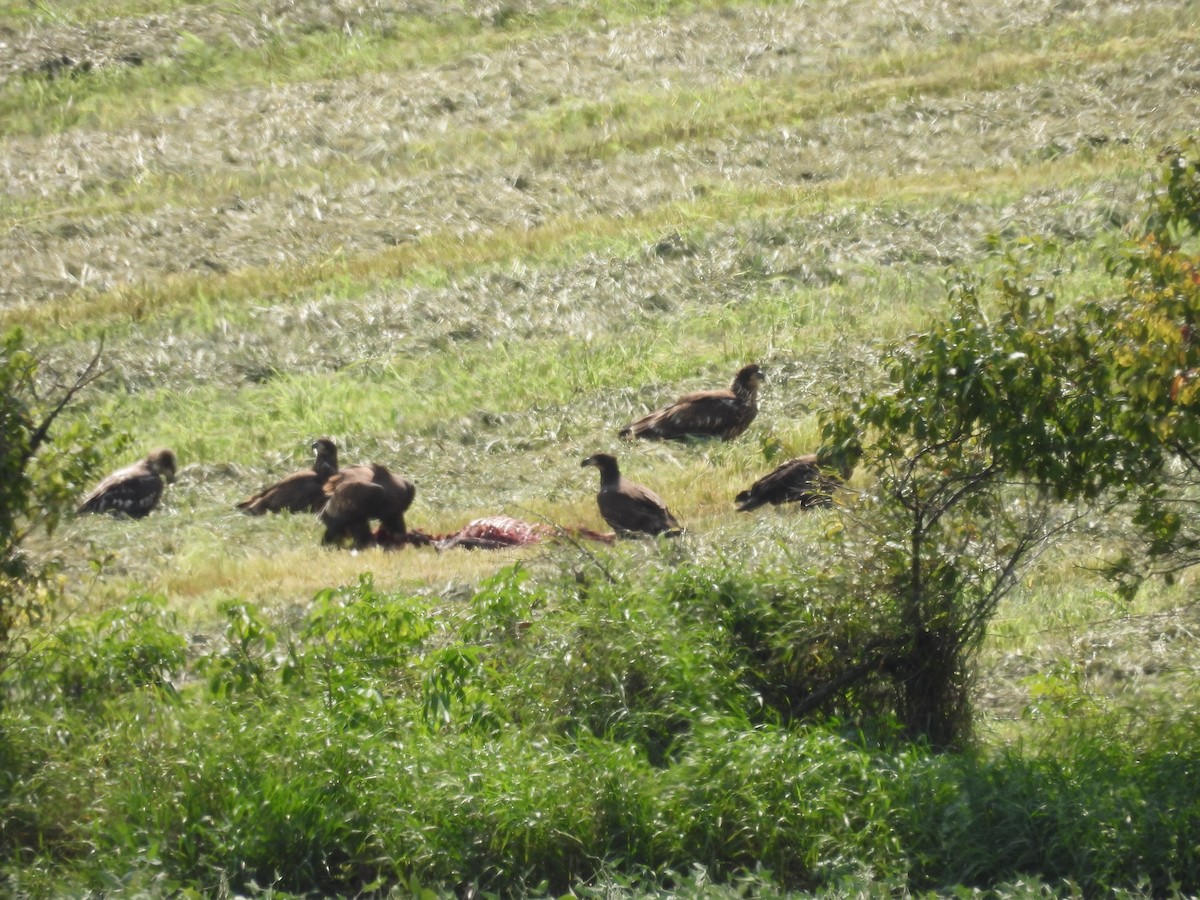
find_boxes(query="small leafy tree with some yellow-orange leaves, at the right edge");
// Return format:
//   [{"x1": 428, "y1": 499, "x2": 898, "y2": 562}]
[{"x1": 797, "y1": 144, "x2": 1200, "y2": 746}]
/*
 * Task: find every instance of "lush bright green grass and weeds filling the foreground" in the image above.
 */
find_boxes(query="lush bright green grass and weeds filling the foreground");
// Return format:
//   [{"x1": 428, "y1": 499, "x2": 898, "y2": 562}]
[{"x1": 4, "y1": 564, "x2": 1200, "y2": 895}]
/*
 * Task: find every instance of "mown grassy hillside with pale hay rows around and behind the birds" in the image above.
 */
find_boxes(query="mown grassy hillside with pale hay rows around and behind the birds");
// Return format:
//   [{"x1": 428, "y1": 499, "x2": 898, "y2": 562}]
[{"x1": 0, "y1": 0, "x2": 1200, "y2": 893}]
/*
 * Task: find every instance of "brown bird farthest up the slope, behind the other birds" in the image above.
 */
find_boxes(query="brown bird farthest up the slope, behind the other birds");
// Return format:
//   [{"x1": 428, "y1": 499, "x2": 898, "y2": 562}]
[{"x1": 617, "y1": 365, "x2": 763, "y2": 440}]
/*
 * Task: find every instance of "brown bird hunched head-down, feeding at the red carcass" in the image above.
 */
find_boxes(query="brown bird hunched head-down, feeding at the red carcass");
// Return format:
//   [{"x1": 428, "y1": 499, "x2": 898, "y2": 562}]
[{"x1": 320, "y1": 463, "x2": 416, "y2": 550}]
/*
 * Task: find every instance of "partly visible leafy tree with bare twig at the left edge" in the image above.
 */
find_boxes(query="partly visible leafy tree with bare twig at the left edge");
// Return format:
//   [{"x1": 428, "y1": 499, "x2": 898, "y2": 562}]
[{"x1": 0, "y1": 330, "x2": 110, "y2": 686}]
